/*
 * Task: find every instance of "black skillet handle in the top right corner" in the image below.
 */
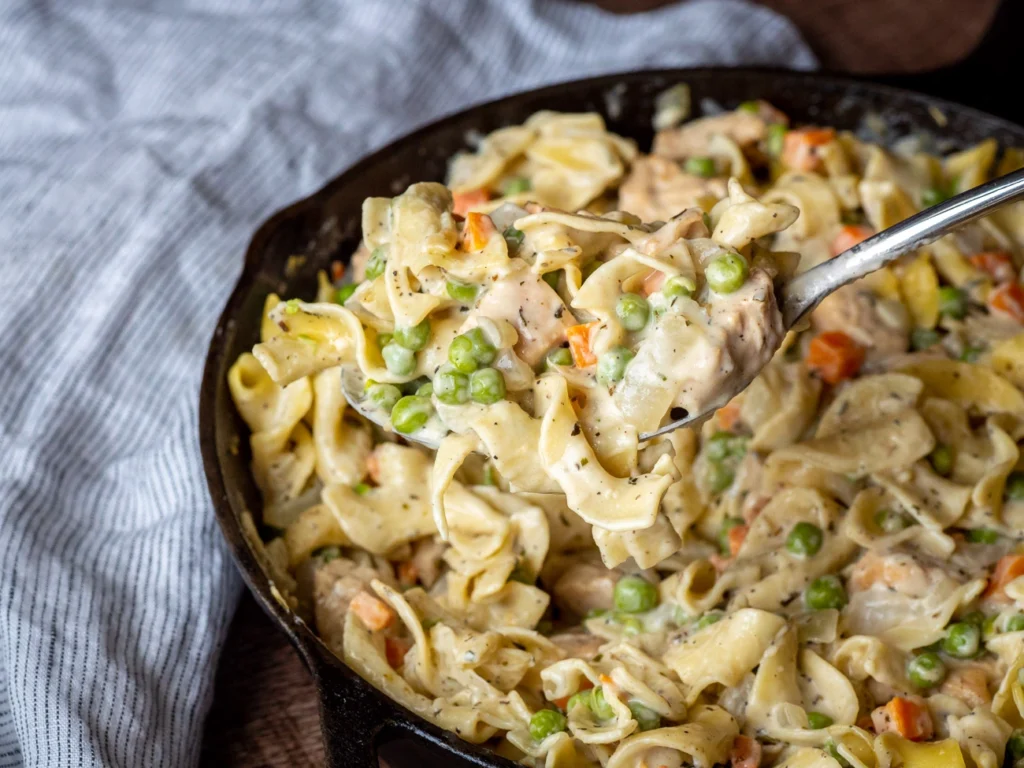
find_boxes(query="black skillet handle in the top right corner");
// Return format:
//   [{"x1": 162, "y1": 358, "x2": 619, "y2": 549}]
[{"x1": 869, "y1": 0, "x2": 1024, "y2": 124}]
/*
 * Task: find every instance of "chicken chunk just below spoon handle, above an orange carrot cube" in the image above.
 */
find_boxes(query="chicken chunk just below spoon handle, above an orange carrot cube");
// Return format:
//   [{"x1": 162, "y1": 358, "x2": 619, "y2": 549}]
[{"x1": 811, "y1": 285, "x2": 910, "y2": 357}]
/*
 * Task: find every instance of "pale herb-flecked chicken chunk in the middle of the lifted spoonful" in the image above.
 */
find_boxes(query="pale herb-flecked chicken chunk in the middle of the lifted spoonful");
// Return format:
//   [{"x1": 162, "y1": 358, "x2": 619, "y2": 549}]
[{"x1": 473, "y1": 264, "x2": 575, "y2": 366}]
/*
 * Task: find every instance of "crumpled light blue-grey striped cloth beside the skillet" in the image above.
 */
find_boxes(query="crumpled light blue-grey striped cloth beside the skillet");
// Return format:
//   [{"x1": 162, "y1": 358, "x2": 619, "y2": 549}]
[{"x1": 0, "y1": 0, "x2": 815, "y2": 768}]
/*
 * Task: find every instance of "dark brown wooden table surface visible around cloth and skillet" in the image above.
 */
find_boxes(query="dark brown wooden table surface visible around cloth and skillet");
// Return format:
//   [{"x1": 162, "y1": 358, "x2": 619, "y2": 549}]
[{"x1": 202, "y1": 0, "x2": 996, "y2": 768}]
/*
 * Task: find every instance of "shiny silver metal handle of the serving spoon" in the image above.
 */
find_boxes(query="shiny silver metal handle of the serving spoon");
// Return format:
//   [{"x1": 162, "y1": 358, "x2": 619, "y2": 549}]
[{"x1": 781, "y1": 169, "x2": 1024, "y2": 328}]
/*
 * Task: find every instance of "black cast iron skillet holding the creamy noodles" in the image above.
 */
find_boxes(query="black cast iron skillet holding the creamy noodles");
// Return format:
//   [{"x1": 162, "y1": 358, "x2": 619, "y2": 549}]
[{"x1": 200, "y1": 0, "x2": 1024, "y2": 768}]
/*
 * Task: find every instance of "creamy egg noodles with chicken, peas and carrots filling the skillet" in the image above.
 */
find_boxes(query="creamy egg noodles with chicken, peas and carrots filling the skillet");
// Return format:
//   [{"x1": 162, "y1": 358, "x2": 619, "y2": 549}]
[{"x1": 228, "y1": 100, "x2": 1024, "y2": 768}]
